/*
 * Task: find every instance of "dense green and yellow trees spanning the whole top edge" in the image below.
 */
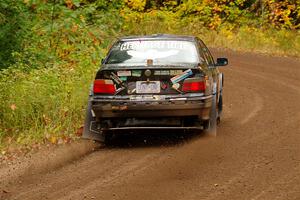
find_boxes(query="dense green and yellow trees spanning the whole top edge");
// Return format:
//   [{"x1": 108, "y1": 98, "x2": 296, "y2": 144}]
[{"x1": 0, "y1": 0, "x2": 300, "y2": 69}]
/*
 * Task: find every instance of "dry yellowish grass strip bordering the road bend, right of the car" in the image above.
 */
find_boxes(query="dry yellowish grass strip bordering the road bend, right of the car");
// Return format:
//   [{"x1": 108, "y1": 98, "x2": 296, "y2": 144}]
[{"x1": 203, "y1": 27, "x2": 300, "y2": 57}]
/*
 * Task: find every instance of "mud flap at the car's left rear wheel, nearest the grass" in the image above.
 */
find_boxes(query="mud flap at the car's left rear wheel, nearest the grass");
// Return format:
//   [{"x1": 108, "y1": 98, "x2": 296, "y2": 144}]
[{"x1": 82, "y1": 100, "x2": 105, "y2": 142}]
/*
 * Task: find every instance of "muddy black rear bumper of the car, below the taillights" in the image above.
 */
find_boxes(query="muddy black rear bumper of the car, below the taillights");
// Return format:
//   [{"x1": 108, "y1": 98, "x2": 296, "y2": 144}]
[{"x1": 90, "y1": 94, "x2": 212, "y2": 120}]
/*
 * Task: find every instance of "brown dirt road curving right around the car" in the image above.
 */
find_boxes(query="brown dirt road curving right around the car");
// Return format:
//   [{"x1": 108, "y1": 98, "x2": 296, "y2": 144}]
[{"x1": 0, "y1": 50, "x2": 300, "y2": 200}]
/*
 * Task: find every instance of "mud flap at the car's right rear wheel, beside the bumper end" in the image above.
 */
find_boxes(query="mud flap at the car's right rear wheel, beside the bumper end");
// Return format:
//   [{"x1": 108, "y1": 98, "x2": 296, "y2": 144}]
[{"x1": 204, "y1": 95, "x2": 218, "y2": 137}]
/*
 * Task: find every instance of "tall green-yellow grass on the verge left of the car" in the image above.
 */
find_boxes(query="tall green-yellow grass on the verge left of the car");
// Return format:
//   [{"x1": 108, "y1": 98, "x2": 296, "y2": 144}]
[{"x1": 0, "y1": 58, "x2": 97, "y2": 148}]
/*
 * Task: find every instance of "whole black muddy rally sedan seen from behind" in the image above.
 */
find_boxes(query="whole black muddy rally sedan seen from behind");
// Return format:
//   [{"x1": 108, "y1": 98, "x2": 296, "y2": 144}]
[{"x1": 83, "y1": 34, "x2": 228, "y2": 141}]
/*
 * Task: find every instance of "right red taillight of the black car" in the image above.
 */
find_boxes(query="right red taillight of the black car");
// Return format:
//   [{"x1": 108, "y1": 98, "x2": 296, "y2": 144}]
[{"x1": 182, "y1": 78, "x2": 206, "y2": 92}]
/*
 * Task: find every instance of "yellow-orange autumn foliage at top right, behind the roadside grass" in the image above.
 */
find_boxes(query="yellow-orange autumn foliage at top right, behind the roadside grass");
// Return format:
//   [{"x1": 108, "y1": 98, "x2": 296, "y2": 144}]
[{"x1": 125, "y1": 0, "x2": 300, "y2": 30}]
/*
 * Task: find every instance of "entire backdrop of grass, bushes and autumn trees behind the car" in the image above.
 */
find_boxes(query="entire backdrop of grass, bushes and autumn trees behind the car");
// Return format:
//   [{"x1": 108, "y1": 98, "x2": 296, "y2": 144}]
[{"x1": 0, "y1": 0, "x2": 300, "y2": 154}]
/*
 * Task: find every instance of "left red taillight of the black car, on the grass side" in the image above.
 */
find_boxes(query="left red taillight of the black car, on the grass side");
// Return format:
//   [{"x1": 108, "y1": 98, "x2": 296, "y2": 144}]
[{"x1": 93, "y1": 79, "x2": 116, "y2": 94}]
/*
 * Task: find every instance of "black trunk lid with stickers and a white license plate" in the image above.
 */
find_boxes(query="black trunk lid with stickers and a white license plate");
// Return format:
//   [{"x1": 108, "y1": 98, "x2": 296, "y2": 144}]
[{"x1": 96, "y1": 67, "x2": 205, "y2": 95}]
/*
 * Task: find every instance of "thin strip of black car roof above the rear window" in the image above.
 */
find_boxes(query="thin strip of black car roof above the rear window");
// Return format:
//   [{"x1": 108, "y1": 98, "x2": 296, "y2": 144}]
[{"x1": 119, "y1": 34, "x2": 196, "y2": 42}]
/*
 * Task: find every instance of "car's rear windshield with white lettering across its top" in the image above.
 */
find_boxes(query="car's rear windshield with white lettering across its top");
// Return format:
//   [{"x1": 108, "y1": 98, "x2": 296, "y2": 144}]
[{"x1": 106, "y1": 40, "x2": 199, "y2": 65}]
